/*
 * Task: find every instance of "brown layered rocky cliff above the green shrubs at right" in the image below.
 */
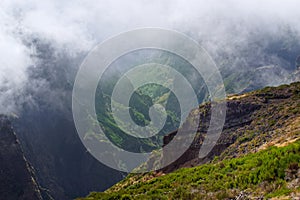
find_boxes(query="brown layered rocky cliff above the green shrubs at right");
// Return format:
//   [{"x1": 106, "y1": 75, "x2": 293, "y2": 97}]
[{"x1": 163, "y1": 82, "x2": 300, "y2": 173}]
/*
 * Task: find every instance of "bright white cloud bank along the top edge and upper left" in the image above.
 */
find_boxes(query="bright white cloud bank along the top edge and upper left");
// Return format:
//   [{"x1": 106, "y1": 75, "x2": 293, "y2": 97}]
[{"x1": 0, "y1": 0, "x2": 300, "y2": 112}]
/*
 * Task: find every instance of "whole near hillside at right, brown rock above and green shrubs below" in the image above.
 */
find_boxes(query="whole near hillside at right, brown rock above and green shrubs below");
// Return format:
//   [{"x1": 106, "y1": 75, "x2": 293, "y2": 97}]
[{"x1": 79, "y1": 82, "x2": 300, "y2": 199}]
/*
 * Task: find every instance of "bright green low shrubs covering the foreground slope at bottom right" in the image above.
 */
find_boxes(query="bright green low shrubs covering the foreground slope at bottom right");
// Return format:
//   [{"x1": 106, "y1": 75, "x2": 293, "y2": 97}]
[{"x1": 78, "y1": 140, "x2": 300, "y2": 200}]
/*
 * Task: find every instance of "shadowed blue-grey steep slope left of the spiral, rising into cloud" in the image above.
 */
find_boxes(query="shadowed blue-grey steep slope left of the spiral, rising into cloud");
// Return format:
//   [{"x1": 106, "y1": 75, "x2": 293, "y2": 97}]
[{"x1": 12, "y1": 39, "x2": 123, "y2": 200}]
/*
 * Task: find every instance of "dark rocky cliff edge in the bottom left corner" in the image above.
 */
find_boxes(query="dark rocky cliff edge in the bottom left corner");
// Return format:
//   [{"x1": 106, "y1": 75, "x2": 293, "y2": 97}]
[{"x1": 0, "y1": 116, "x2": 42, "y2": 200}]
